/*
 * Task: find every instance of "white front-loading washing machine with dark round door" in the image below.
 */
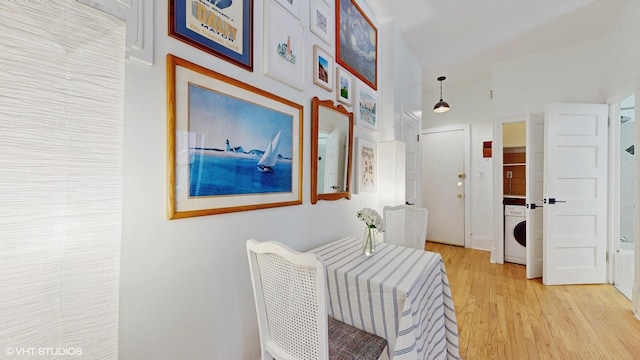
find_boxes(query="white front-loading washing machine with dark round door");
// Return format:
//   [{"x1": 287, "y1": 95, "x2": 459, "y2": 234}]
[{"x1": 504, "y1": 205, "x2": 527, "y2": 265}]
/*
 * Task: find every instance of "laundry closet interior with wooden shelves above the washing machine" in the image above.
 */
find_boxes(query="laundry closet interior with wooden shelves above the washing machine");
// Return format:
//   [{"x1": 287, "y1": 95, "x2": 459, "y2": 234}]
[{"x1": 502, "y1": 121, "x2": 527, "y2": 265}]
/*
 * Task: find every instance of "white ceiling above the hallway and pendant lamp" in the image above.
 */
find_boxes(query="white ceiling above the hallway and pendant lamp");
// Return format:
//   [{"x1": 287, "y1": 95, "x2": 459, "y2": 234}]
[{"x1": 365, "y1": 0, "x2": 635, "y2": 90}]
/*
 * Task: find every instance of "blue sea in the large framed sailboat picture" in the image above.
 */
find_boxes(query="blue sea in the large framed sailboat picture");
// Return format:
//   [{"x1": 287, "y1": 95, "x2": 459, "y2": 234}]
[{"x1": 189, "y1": 154, "x2": 292, "y2": 196}]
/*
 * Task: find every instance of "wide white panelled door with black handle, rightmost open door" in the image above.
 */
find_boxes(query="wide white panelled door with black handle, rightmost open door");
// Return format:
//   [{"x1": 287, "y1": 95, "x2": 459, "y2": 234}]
[{"x1": 542, "y1": 104, "x2": 608, "y2": 285}]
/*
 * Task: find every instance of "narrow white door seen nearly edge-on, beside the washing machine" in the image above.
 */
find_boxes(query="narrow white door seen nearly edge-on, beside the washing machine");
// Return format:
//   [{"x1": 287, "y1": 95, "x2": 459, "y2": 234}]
[{"x1": 526, "y1": 114, "x2": 544, "y2": 279}]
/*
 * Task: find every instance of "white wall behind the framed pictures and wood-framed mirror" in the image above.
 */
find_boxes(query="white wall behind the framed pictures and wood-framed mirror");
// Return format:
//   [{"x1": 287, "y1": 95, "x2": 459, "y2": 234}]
[{"x1": 119, "y1": 0, "x2": 419, "y2": 360}]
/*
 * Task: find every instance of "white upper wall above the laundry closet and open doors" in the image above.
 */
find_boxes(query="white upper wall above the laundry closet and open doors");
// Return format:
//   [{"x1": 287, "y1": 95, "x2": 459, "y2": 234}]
[{"x1": 493, "y1": 1, "x2": 640, "y2": 118}]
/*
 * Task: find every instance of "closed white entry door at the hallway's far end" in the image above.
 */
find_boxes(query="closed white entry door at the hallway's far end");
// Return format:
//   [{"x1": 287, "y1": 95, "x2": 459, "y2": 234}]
[{"x1": 420, "y1": 127, "x2": 468, "y2": 246}]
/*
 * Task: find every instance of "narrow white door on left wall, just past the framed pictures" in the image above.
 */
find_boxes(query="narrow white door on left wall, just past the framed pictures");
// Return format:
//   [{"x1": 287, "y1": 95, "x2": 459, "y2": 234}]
[{"x1": 399, "y1": 112, "x2": 423, "y2": 207}]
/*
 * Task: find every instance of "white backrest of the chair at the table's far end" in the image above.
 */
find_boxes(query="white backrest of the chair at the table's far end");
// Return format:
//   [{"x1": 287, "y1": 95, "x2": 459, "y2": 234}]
[{"x1": 382, "y1": 205, "x2": 429, "y2": 250}]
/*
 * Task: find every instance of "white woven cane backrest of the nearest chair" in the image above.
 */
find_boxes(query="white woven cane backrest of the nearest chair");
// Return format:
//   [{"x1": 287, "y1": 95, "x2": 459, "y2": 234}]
[{"x1": 247, "y1": 239, "x2": 329, "y2": 360}]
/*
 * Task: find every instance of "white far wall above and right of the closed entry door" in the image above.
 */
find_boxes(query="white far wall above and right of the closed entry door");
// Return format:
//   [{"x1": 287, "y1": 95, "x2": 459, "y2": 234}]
[{"x1": 422, "y1": 79, "x2": 494, "y2": 250}]
